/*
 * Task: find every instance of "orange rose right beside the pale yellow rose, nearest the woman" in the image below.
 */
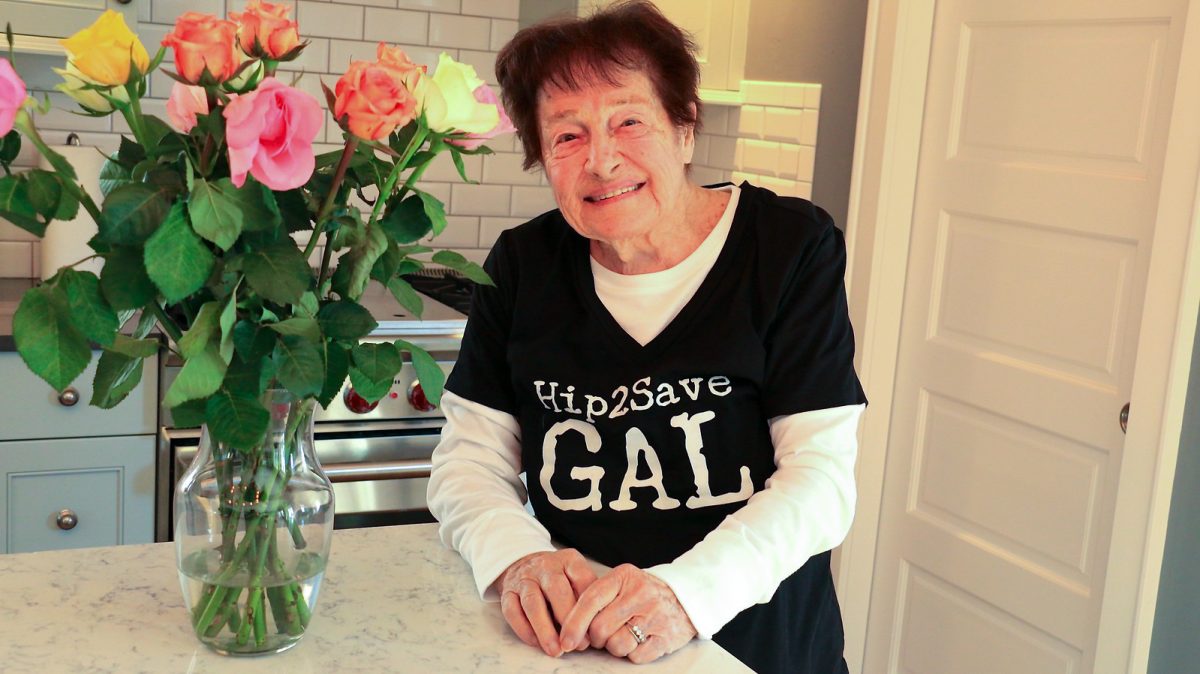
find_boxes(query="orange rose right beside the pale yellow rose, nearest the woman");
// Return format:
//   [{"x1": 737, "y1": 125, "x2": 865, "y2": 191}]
[{"x1": 334, "y1": 42, "x2": 422, "y2": 140}]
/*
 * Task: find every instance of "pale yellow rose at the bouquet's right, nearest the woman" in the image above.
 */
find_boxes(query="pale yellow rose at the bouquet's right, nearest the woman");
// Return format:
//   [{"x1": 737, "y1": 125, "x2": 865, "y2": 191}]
[{"x1": 414, "y1": 52, "x2": 500, "y2": 133}]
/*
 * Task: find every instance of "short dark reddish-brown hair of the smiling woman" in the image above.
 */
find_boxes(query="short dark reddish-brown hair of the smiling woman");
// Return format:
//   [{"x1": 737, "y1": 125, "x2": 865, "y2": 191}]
[{"x1": 496, "y1": 0, "x2": 701, "y2": 169}]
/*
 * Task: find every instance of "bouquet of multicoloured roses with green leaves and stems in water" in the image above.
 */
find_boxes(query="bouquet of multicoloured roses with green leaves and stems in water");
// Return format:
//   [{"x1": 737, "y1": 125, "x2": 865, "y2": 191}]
[{"x1": 0, "y1": 0, "x2": 512, "y2": 650}]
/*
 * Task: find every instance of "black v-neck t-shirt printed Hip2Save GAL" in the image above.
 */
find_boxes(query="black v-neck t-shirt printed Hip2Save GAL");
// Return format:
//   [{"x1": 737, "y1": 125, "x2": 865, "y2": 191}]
[{"x1": 446, "y1": 183, "x2": 865, "y2": 674}]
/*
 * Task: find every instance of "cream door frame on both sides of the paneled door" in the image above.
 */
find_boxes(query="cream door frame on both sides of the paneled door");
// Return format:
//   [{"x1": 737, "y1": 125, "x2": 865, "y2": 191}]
[{"x1": 836, "y1": 0, "x2": 1200, "y2": 674}]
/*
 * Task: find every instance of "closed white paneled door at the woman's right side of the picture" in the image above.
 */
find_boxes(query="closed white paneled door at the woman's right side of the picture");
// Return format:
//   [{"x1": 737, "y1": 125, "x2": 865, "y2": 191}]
[{"x1": 863, "y1": 0, "x2": 1200, "y2": 674}]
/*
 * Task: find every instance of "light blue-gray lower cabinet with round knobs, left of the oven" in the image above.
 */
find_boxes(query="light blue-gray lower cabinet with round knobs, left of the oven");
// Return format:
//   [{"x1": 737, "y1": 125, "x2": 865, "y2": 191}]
[{"x1": 0, "y1": 351, "x2": 158, "y2": 553}]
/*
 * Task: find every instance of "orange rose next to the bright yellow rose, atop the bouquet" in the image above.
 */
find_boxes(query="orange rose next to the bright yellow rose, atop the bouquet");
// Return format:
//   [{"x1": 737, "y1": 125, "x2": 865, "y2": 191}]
[{"x1": 162, "y1": 12, "x2": 241, "y2": 85}]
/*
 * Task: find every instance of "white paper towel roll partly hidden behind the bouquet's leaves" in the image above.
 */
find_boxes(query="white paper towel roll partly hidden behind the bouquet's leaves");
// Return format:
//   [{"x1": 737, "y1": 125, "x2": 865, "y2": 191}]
[{"x1": 38, "y1": 145, "x2": 104, "y2": 279}]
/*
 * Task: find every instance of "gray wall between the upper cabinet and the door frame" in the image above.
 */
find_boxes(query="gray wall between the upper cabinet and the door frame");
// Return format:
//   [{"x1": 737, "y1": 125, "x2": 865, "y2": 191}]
[{"x1": 745, "y1": 0, "x2": 866, "y2": 228}]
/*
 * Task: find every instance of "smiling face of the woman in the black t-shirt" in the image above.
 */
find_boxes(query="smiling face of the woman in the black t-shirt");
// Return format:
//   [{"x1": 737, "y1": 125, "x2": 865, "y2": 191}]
[{"x1": 538, "y1": 71, "x2": 695, "y2": 242}]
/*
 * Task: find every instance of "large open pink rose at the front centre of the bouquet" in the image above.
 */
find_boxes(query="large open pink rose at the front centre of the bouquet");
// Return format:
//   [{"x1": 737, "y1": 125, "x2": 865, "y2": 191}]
[{"x1": 224, "y1": 77, "x2": 325, "y2": 189}]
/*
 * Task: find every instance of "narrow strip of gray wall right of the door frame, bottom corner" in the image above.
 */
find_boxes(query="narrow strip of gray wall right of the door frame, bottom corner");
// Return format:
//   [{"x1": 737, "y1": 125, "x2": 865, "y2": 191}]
[{"x1": 1148, "y1": 305, "x2": 1200, "y2": 674}]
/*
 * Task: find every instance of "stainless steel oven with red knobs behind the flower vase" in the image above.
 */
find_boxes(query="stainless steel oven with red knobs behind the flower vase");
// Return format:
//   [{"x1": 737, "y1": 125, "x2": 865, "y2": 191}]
[{"x1": 155, "y1": 280, "x2": 466, "y2": 541}]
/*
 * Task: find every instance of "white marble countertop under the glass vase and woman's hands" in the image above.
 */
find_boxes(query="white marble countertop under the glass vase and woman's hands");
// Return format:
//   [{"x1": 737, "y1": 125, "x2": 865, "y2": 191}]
[{"x1": 0, "y1": 524, "x2": 749, "y2": 674}]
